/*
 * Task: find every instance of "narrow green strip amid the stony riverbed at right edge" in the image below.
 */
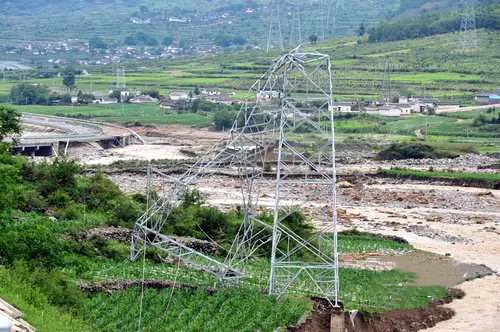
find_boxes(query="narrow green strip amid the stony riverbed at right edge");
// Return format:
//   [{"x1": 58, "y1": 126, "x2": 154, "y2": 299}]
[{"x1": 380, "y1": 168, "x2": 500, "y2": 189}]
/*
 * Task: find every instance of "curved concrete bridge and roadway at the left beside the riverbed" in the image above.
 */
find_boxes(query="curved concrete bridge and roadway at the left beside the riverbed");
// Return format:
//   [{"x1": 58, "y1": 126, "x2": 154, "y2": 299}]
[{"x1": 7, "y1": 113, "x2": 144, "y2": 156}]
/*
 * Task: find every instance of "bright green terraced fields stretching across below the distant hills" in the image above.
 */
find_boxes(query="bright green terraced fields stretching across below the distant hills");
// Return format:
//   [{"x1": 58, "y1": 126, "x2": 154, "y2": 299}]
[{"x1": 0, "y1": 30, "x2": 500, "y2": 104}]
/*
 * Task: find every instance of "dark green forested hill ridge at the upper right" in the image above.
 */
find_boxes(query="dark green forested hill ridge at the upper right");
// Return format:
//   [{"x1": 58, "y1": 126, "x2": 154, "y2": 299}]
[{"x1": 368, "y1": 4, "x2": 500, "y2": 42}]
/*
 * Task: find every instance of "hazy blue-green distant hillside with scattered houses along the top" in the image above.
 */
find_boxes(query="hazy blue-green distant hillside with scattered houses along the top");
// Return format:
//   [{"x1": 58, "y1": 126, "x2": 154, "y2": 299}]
[{"x1": 0, "y1": 0, "x2": 458, "y2": 45}]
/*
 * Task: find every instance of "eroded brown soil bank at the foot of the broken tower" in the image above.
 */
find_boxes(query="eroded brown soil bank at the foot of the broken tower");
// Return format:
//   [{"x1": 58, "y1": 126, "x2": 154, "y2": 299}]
[{"x1": 288, "y1": 288, "x2": 465, "y2": 332}]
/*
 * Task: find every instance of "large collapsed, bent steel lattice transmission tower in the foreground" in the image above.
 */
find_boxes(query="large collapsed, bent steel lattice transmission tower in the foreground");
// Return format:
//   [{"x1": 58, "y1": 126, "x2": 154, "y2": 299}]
[{"x1": 131, "y1": 48, "x2": 339, "y2": 305}]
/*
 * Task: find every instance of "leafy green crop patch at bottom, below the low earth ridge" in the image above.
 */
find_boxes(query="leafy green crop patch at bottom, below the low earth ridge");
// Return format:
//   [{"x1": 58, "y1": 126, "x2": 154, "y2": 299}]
[{"x1": 85, "y1": 288, "x2": 311, "y2": 332}]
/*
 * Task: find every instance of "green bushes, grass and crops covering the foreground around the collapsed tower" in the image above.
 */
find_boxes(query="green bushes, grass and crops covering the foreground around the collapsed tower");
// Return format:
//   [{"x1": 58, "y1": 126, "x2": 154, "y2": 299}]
[{"x1": 0, "y1": 108, "x2": 452, "y2": 332}]
